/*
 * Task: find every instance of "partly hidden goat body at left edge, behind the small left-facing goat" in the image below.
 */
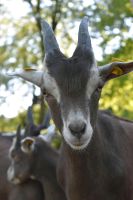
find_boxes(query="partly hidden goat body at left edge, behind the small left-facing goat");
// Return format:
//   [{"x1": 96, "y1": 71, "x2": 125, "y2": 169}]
[{"x1": 0, "y1": 131, "x2": 44, "y2": 200}]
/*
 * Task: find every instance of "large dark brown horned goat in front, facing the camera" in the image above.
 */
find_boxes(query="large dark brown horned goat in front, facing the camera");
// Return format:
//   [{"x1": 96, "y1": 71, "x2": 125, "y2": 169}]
[{"x1": 8, "y1": 17, "x2": 133, "y2": 200}]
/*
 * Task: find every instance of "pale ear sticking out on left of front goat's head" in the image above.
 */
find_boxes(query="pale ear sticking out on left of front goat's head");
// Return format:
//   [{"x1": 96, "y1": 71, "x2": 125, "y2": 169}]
[{"x1": 7, "y1": 69, "x2": 44, "y2": 87}]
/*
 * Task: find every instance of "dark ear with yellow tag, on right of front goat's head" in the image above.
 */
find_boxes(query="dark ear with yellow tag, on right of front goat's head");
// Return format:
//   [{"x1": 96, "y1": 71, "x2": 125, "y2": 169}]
[{"x1": 98, "y1": 62, "x2": 133, "y2": 82}]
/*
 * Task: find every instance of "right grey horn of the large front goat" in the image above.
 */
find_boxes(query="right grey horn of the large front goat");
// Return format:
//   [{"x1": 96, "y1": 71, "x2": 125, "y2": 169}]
[{"x1": 78, "y1": 16, "x2": 92, "y2": 49}]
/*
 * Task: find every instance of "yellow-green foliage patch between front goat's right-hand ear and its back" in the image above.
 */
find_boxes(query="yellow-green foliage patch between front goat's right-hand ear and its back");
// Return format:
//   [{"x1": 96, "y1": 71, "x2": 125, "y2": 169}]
[{"x1": 100, "y1": 74, "x2": 133, "y2": 120}]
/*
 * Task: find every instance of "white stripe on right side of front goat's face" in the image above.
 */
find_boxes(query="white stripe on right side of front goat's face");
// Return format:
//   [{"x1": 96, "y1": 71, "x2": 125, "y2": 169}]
[{"x1": 87, "y1": 67, "x2": 100, "y2": 99}]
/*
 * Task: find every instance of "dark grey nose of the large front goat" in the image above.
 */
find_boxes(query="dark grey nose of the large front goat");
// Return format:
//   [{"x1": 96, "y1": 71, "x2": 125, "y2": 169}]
[{"x1": 69, "y1": 122, "x2": 86, "y2": 138}]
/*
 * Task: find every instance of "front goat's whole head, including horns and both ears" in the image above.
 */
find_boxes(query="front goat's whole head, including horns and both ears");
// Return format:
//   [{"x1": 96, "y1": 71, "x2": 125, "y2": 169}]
[{"x1": 9, "y1": 17, "x2": 133, "y2": 150}]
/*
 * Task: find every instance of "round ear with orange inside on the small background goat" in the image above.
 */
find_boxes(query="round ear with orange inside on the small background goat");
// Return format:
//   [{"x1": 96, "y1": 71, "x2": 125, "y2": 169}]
[{"x1": 21, "y1": 137, "x2": 35, "y2": 153}]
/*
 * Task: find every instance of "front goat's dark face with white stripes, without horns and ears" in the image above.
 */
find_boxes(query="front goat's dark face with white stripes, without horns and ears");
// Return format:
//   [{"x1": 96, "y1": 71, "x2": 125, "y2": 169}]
[{"x1": 44, "y1": 49, "x2": 99, "y2": 150}]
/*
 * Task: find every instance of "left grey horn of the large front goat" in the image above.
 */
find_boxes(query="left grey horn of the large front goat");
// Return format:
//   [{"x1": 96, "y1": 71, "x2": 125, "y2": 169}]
[{"x1": 41, "y1": 20, "x2": 60, "y2": 53}]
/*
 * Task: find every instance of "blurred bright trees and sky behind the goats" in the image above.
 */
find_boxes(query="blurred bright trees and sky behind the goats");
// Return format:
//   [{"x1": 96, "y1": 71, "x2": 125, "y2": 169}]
[{"x1": 0, "y1": 0, "x2": 133, "y2": 132}]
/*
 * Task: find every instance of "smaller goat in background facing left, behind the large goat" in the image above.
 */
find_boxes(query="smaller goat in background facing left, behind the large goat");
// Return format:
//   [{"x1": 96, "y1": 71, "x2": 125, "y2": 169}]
[{"x1": 8, "y1": 126, "x2": 66, "y2": 200}]
